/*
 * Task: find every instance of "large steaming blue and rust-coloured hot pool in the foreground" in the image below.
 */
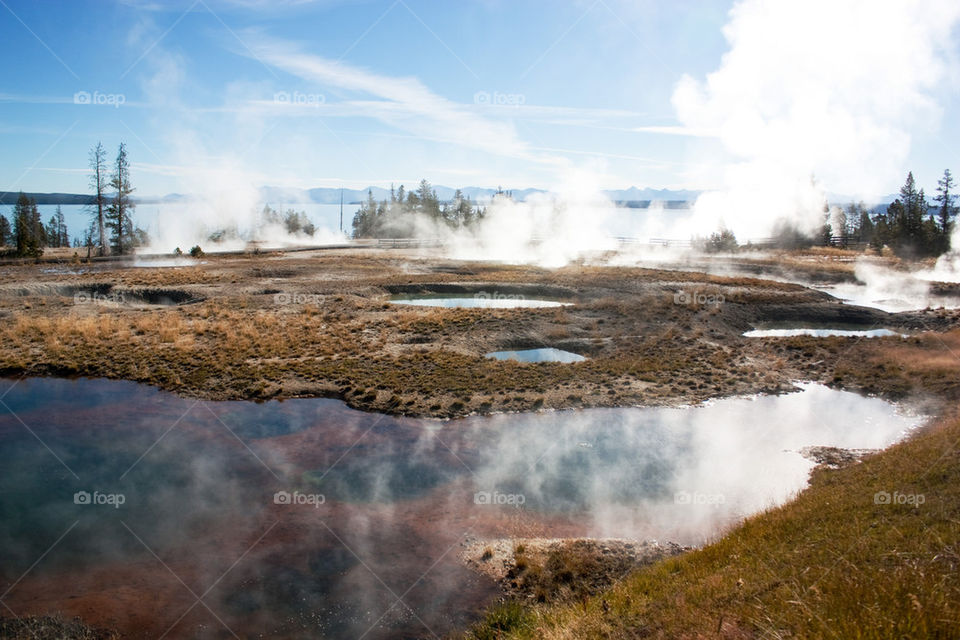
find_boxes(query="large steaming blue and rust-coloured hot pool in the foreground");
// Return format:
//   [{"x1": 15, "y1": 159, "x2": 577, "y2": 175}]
[{"x1": 0, "y1": 379, "x2": 920, "y2": 638}]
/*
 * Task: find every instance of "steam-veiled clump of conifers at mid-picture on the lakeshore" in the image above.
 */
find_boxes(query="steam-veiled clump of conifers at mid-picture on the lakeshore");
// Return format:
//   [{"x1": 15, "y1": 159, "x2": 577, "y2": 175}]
[{"x1": 353, "y1": 179, "x2": 484, "y2": 238}]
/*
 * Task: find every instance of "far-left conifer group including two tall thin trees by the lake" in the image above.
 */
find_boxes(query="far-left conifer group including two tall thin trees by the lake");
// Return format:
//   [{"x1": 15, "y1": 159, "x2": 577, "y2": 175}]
[{"x1": 0, "y1": 142, "x2": 147, "y2": 258}]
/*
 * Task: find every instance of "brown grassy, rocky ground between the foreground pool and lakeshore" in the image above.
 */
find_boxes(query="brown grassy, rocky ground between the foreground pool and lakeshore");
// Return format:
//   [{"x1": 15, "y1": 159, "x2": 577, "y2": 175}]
[{"x1": 0, "y1": 250, "x2": 960, "y2": 417}]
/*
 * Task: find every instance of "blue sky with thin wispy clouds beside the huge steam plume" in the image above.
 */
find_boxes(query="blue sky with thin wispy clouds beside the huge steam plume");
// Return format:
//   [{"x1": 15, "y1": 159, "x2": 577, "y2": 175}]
[{"x1": 0, "y1": 0, "x2": 960, "y2": 195}]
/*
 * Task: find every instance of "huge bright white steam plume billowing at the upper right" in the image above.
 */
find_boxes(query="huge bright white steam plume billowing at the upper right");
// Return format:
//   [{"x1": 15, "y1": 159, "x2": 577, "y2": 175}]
[{"x1": 673, "y1": 0, "x2": 960, "y2": 236}]
